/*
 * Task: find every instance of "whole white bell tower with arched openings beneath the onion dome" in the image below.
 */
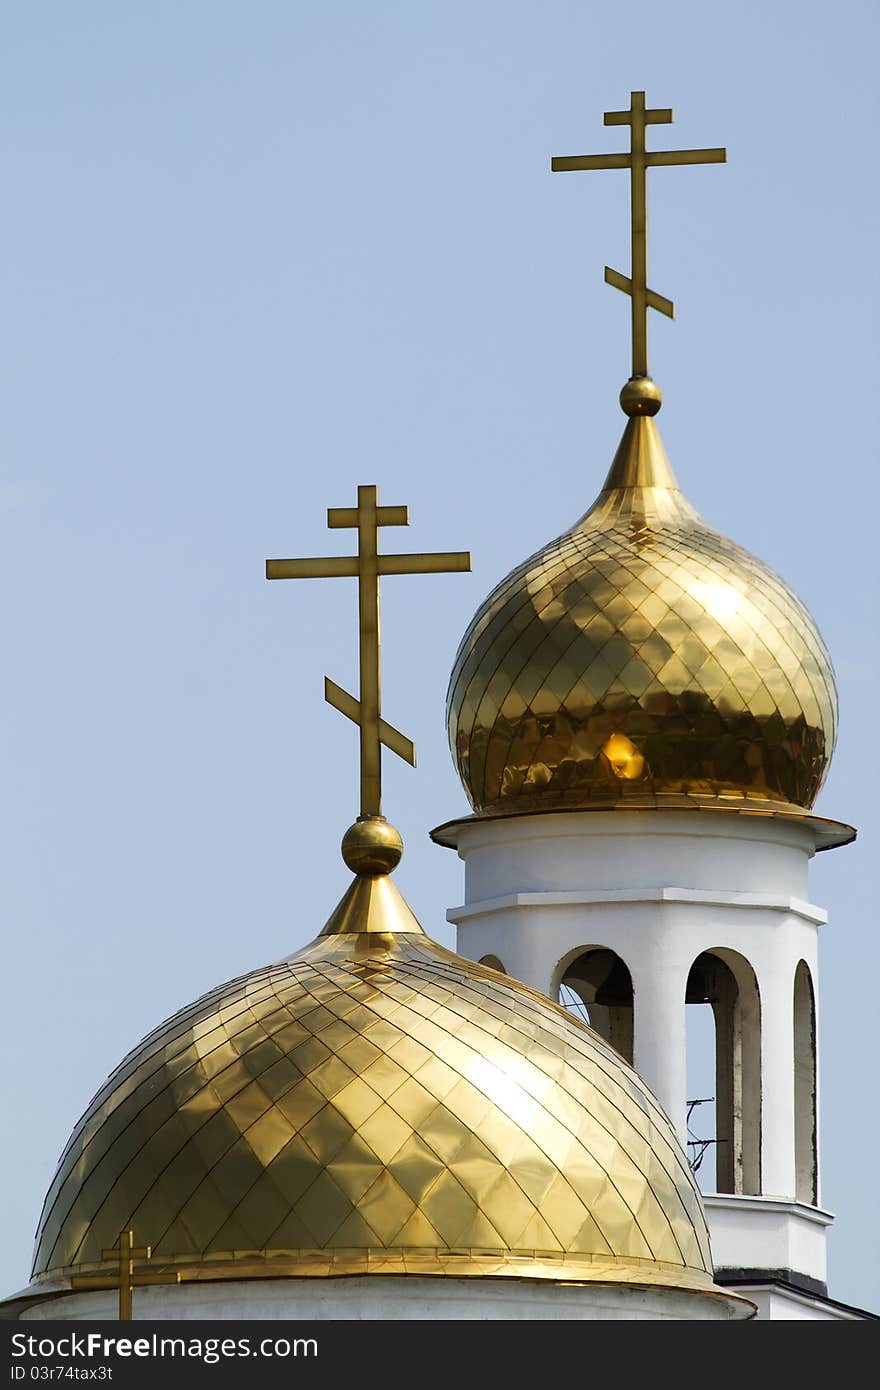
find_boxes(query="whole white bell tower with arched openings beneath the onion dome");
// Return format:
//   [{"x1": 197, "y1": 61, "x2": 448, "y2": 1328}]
[{"x1": 434, "y1": 809, "x2": 852, "y2": 1297}]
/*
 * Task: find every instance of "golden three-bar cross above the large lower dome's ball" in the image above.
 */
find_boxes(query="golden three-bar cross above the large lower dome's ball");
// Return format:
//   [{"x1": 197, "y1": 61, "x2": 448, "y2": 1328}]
[{"x1": 266, "y1": 487, "x2": 470, "y2": 819}]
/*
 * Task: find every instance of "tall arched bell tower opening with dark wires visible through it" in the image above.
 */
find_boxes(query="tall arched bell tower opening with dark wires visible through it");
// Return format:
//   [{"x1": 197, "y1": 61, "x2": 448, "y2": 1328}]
[{"x1": 685, "y1": 947, "x2": 760, "y2": 1195}]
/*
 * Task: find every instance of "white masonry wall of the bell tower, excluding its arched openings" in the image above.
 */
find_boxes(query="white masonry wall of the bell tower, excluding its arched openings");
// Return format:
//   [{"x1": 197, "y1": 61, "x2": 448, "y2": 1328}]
[{"x1": 448, "y1": 810, "x2": 831, "y2": 1282}]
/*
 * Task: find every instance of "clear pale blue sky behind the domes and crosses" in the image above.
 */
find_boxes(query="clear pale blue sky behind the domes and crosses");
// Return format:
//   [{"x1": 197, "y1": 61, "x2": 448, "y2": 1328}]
[{"x1": 0, "y1": 0, "x2": 880, "y2": 1308}]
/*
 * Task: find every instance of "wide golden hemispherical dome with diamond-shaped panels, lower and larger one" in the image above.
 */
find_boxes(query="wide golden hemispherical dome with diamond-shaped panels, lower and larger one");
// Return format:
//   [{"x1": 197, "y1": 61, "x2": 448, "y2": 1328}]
[{"x1": 28, "y1": 850, "x2": 720, "y2": 1297}]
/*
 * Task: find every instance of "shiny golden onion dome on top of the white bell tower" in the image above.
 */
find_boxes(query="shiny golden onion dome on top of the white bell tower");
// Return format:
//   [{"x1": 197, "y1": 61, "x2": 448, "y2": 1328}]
[{"x1": 448, "y1": 405, "x2": 837, "y2": 813}]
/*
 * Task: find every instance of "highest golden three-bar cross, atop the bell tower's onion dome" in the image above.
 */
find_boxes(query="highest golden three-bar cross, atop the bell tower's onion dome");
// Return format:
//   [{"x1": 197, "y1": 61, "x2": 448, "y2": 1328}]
[{"x1": 551, "y1": 92, "x2": 727, "y2": 377}]
